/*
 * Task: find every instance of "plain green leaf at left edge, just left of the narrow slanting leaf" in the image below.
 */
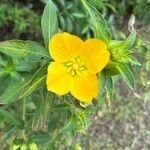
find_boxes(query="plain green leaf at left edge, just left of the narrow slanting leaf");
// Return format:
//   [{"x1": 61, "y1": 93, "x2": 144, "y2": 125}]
[{"x1": 0, "y1": 79, "x2": 28, "y2": 103}]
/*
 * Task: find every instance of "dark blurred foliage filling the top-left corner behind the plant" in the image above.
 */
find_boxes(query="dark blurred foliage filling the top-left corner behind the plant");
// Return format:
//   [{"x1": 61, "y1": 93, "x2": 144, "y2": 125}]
[{"x1": 0, "y1": 0, "x2": 41, "y2": 39}]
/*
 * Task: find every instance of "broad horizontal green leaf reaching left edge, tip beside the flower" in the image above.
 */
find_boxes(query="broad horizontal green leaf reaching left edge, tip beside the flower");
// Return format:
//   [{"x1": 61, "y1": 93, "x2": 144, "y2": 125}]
[{"x1": 0, "y1": 40, "x2": 49, "y2": 61}]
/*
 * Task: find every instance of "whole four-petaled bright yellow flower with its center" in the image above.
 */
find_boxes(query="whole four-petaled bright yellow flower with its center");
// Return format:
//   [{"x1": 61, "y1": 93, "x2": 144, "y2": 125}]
[{"x1": 46, "y1": 33, "x2": 110, "y2": 102}]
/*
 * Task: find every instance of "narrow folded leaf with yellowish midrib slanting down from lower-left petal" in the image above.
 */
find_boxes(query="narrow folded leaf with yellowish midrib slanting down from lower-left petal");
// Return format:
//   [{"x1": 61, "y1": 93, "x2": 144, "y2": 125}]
[{"x1": 19, "y1": 64, "x2": 48, "y2": 98}]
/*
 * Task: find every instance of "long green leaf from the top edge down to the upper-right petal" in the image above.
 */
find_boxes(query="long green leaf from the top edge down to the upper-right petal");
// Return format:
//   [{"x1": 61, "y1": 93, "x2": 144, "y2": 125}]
[{"x1": 81, "y1": 0, "x2": 111, "y2": 44}]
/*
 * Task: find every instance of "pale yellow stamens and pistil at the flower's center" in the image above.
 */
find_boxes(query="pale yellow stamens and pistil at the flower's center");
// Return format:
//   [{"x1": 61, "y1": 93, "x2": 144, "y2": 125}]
[{"x1": 65, "y1": 57, "x2": 87, "y2": 76}]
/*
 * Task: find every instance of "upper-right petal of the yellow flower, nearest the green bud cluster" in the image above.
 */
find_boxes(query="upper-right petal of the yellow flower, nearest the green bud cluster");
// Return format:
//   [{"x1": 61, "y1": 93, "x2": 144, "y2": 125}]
[{"x1": 81, "y1": 39, "x2": 110, "y2": 73}]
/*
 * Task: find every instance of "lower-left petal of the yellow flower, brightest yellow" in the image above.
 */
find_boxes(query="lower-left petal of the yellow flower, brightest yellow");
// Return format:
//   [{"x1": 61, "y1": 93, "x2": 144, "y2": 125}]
[{"x1": 46, "y1": 62, "x2": 71, "y2": 95}]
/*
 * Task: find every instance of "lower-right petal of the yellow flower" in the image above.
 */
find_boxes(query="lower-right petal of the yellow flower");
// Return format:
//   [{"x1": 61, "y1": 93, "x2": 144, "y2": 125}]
[{"x1": 70, "y1": 73, "x2": 98, "y2": 102}]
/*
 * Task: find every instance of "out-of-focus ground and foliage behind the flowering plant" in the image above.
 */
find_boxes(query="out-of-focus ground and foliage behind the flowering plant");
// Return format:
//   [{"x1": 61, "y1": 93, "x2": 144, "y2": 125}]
[{"x1": 0, "y1": 0, "x2": 150, "y2": 150}]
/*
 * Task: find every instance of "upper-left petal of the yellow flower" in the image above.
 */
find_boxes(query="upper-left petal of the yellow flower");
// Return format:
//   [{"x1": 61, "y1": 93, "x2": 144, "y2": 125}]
[{"x1": 49, "y1": 33, "x2": 83, "y2": 63}]
